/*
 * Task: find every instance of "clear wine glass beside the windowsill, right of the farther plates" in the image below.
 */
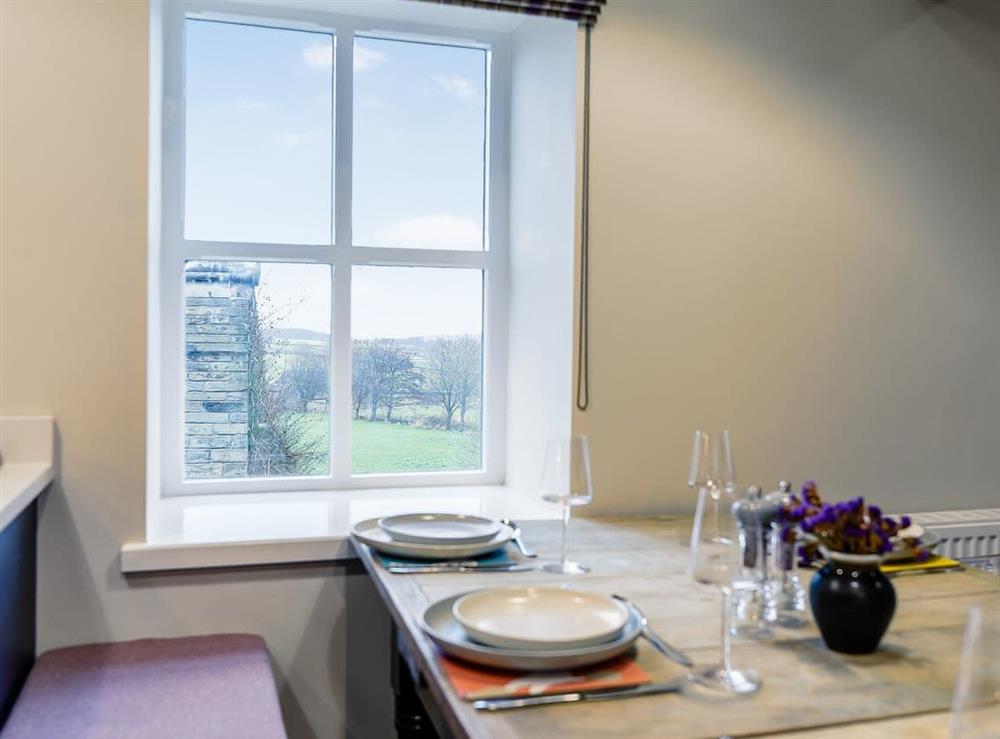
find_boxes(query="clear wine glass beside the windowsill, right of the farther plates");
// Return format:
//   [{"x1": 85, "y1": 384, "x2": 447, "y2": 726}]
[{"x1": 539, "y1": 436, "x2": 594, "y2": 575}]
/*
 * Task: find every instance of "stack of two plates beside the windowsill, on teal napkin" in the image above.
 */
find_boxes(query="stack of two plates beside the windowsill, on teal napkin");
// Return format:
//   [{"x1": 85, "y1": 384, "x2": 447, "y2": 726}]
[{"x1": 351, "y1": 513, "x2": 514, "y2": 560}]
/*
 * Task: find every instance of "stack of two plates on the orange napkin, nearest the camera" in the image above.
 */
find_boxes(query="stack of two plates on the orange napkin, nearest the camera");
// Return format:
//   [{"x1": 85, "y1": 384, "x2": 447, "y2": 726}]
[{"x1": 423, "y1": 587, "x2": 641, "y2": 671}]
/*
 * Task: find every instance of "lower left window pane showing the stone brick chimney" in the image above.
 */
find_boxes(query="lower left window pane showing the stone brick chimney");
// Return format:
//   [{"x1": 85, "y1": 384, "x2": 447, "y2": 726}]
[{"x1": 184, "y1": 261, "x2": 331, "y2": 479}]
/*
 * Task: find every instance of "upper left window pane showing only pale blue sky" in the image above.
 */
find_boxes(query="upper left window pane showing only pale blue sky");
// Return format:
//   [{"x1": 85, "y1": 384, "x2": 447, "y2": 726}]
[{"x1": 184, "y1": 20, "x2": 333, "y2": 244}]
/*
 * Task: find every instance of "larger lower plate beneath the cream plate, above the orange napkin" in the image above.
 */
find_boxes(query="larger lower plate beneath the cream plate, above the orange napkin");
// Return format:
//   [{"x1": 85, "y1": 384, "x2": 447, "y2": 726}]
[{"x1": 423, "y1": 595, "x2": 640, "y2": 672}]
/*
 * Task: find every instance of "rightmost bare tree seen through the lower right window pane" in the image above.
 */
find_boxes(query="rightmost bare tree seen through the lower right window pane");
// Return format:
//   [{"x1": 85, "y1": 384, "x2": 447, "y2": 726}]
[{"x1": 426, "y1": 334, "x2": 482, "y2": 429}]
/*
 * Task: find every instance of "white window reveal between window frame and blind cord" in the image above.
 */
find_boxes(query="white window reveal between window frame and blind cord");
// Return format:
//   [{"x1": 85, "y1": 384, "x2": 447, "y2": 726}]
[{"x1": 507, "y1": 19, "x2": 577, "y2": 494}]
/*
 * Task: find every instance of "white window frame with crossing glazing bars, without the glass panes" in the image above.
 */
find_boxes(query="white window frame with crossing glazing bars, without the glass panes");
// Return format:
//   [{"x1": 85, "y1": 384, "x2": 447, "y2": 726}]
[{"x1": 161, "y1": 1, "x2": 510, "y2": 496}]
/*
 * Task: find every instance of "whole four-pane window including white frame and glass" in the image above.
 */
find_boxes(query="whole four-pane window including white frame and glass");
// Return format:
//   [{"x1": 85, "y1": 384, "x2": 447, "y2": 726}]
[{"x1": 158, "y1": 3, "x2": 508, "y2": 495}]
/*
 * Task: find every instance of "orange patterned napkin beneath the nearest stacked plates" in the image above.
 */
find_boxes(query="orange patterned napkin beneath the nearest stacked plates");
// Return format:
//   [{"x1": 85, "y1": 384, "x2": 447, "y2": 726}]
[{"x1": 438, "y1": 655, "x2": 650, "y2": 701}]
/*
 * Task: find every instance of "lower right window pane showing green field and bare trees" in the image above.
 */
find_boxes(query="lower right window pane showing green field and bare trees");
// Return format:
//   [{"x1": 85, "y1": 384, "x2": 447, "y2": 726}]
[{"x1": 351, "y1": 267, "x2": 483, "y2": 474}]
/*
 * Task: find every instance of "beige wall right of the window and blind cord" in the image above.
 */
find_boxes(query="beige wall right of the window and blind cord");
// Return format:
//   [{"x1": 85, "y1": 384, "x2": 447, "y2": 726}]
[{"x1": 575, "y1": 0, "x2": 1000, "y2": 512}]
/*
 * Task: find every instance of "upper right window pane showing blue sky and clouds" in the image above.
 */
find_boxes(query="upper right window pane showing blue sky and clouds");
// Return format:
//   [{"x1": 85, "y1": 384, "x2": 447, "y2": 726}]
[{"x1": 353, "y1": 37, "x2": 486, "y2": 250}]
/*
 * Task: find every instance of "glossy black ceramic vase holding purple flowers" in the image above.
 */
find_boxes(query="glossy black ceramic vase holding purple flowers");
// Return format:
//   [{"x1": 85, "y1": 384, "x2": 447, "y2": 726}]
[{"x1": 809, "y1": 552, "x2": 896, "y2": 654}]
